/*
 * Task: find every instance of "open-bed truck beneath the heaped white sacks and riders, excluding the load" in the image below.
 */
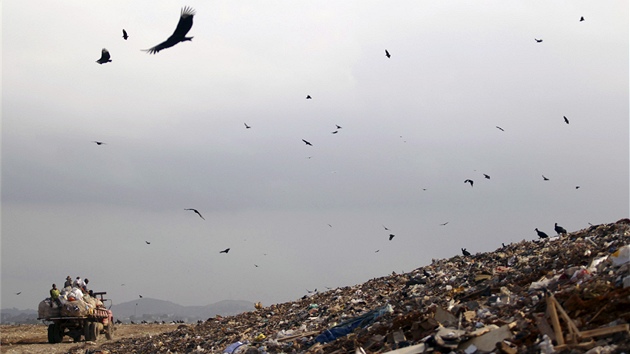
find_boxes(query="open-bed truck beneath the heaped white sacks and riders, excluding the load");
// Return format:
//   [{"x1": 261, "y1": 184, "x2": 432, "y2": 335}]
[{"x1": 38, "y1": 292, "x2": 114, "y2": 344}]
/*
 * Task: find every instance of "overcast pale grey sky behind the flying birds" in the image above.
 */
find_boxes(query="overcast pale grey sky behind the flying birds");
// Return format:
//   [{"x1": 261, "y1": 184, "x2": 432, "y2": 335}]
[{"x1": 0, "y1": 0, "x2": 629, "y2": 309}]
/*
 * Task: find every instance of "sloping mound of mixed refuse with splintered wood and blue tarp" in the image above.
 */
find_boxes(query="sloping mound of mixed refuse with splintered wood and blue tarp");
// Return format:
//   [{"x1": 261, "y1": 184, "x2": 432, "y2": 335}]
[{"x1": 83, "y1": 219, "x2": 630, "y2": 354}]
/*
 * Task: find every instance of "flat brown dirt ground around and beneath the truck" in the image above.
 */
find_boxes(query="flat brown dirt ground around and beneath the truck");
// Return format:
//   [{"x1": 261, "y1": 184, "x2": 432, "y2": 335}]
[{"x1": 0, "y1": 324, "x2": 177, "y2": 354}]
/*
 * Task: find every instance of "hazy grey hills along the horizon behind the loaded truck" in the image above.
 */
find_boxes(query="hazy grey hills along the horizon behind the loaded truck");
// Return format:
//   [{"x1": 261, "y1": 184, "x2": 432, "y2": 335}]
[{"x1": 0, "y1": 298, "x2": 254, "y2": 324}]
